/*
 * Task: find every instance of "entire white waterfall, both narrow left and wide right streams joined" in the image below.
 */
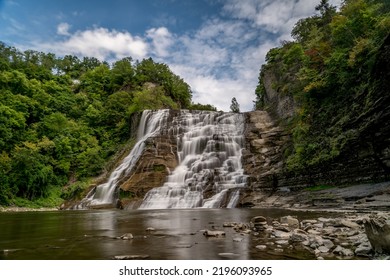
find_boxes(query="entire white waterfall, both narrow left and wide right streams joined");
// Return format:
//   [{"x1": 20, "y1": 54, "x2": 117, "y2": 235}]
[{"x1": 79, "y1": 110, "x2": 246, "y2": 209}]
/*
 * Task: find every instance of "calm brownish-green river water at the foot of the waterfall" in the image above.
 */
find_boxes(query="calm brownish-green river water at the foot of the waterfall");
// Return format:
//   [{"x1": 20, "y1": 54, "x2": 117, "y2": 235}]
[{"x1": 0, "y1": 209, "x2": 344, "y2": 260}]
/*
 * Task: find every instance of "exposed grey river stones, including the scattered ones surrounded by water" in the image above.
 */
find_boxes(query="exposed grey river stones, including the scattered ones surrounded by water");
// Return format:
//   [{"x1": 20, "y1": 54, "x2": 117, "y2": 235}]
[{"x1": 109, "y1": 212, "x2": 390, "y2": 260}]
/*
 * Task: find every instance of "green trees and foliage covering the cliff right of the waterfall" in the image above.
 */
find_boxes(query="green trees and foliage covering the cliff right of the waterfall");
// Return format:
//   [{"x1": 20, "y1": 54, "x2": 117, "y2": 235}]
[{"x1": 255, "y1": 0, "x2": 390, "y2": 170}]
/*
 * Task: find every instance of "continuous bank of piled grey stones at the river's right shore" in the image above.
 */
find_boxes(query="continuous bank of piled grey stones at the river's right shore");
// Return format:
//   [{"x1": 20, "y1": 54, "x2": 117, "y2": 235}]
[{"x1": 227, "y1": 212, "x2": 390, "y2": 260}]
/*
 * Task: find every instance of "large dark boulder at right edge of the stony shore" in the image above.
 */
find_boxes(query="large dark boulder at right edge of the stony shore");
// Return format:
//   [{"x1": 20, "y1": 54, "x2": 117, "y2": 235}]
[{"x1": 364, "y1": 214, "x2": 390, "y2": 254}]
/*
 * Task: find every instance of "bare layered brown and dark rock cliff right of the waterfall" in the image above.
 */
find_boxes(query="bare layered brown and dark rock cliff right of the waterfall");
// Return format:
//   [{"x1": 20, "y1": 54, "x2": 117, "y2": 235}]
[{"x1": 247, "y1": 33, "x2": 390, "y2": 192}]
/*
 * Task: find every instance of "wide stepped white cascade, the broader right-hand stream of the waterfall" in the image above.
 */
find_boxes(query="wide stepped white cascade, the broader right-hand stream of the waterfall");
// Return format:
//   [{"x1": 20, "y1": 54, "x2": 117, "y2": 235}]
[{"x1": 140, "y1": 110, "x2": 246, "y2": 209}]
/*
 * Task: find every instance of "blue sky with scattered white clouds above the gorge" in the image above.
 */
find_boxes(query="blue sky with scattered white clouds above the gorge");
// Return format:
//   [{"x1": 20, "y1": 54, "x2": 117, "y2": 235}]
[{"x1": 0, "y1": 0, "x2": 341, "y2": 112}]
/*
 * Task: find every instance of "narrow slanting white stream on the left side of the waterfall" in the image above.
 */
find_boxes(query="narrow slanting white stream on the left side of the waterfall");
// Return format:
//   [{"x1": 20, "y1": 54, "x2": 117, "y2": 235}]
[{"x1": 76, "y1": 110, "x2": 169, "y2": 209}]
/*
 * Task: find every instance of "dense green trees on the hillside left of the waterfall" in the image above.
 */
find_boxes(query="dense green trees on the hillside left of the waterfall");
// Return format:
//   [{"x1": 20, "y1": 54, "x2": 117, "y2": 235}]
[{"x1": 0, "y1": 43, "x2": 200, "y2": 205}]
